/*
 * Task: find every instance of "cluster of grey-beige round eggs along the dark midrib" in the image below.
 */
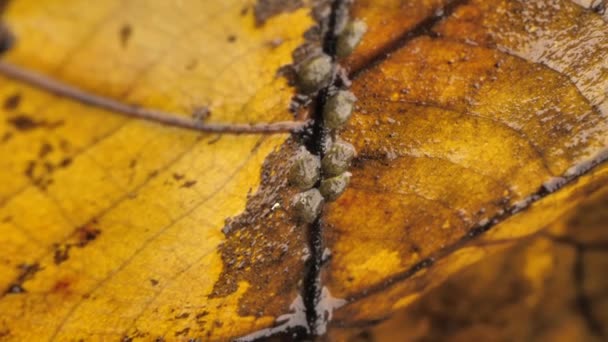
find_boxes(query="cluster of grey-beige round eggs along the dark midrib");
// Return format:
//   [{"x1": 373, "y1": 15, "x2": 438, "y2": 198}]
[{"x1": 289, "y1": 12, "x2": 367, "y2": 224}]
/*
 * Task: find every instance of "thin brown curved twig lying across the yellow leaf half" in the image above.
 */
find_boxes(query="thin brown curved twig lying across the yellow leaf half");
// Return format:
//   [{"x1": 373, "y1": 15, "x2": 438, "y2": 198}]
[{"x1": 0, "y1": 61, "x2": 309, "y2": 134}]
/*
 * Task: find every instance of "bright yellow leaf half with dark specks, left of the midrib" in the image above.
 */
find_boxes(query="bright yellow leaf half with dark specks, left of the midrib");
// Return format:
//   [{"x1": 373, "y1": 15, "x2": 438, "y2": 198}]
[{"x1": 0, "y1": 0, "x2": 312, "y2": 341}]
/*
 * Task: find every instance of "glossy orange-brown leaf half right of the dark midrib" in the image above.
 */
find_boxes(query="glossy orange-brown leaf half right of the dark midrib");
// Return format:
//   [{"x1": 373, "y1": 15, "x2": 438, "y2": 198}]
[{"x1": 322, "y1": 0, "x2": 608, "y2": 325}]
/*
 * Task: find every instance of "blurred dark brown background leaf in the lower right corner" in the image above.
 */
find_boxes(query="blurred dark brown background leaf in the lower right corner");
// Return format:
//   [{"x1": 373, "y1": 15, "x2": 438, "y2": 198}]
[{"x1": 332, "y1": 189, "x2": 608, "y2": 342}]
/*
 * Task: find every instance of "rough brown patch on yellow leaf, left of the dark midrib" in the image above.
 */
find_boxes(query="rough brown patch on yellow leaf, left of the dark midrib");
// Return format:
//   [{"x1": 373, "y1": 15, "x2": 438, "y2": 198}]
[{"x1": 212, "y1": 140, "x2": 307, "y2": 317}]
